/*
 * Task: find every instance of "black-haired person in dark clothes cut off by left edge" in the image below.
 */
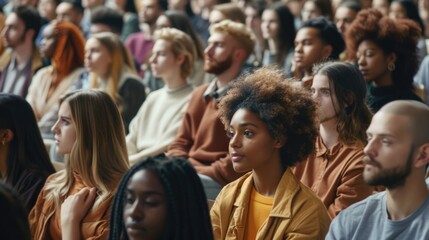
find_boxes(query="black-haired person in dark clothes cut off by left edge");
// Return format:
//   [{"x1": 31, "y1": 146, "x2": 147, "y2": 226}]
[{"x1": 0, "y1": 93, "x2": 55, "y2": 214}]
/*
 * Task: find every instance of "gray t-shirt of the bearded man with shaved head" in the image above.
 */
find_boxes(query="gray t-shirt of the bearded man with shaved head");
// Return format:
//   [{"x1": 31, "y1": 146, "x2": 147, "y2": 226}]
[{"x1": 326, "y1": 192, "x2": 429, "y2": 240}]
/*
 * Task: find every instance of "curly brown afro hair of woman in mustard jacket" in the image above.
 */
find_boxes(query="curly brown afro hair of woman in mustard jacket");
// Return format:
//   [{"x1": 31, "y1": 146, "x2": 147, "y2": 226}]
[{"x1": 219, "y1": 67, "x2": 318, "y2": 167}]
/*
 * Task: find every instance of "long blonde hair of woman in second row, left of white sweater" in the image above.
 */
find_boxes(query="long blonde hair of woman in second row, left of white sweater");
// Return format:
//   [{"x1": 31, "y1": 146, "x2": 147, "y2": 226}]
[{"x1": 89, "y1": 32, "x2": 137, "y2": 109}]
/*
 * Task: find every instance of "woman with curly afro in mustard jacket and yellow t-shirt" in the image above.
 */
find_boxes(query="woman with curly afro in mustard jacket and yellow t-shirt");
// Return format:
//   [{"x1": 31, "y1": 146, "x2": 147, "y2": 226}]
[{"x1": 210, "y1": 68, "x2": 330, "y2": 239}]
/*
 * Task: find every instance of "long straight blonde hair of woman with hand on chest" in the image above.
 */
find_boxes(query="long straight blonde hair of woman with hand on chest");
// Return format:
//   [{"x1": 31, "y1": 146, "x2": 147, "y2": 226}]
[{"x1": 46, "y1": 90, "x2": 129, "y2": 206}]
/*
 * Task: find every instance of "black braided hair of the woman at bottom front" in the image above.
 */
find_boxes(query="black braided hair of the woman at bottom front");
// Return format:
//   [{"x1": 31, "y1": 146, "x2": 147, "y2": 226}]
[{"x1": 109, "y1": 155, "x2": 213, "y2": 240}]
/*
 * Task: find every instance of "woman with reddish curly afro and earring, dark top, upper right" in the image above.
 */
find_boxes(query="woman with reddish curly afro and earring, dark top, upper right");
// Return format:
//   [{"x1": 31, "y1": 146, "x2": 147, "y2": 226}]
[{"x1": 346, "y1": 9, "x2": 421, "y2": 112}]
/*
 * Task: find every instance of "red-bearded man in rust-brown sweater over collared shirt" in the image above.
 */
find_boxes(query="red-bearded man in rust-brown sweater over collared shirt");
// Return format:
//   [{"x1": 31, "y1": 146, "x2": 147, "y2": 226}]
[{"x1": 167, "y1": 20, "x2": 255, "y2": 199}]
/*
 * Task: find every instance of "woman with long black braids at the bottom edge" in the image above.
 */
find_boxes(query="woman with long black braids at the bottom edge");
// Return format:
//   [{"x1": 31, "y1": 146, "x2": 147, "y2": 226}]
[{"x1": 109, "y1": 155, "x2": 213, "y2": 240}]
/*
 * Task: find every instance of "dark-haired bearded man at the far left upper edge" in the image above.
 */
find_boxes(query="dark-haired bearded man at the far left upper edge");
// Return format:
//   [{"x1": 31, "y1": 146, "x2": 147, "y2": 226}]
[{"x1": 0, "y1": 5, "x2": 42, "y2": 97}]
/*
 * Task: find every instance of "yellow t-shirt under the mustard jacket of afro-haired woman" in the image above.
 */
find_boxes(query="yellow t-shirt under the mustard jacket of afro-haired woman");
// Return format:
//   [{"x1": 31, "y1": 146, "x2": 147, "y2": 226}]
[{"x1": 244, "y1": 188, "x2": 274, "y2": 240}]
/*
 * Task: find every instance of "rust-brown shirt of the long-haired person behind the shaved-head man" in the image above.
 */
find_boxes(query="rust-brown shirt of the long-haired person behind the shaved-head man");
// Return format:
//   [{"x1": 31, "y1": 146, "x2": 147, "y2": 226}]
[{"x1": 293, "y1": 137, "x2": 374, "y2": 218}]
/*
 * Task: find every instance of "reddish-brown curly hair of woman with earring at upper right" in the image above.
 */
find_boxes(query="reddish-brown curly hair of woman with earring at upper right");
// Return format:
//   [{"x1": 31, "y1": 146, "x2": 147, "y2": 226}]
[{"x1": 346, "y1": 9, "x2": 421, "y2": 89}]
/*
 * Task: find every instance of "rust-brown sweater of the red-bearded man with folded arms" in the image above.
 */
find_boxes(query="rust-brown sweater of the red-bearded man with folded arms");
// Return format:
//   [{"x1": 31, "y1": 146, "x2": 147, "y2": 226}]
[{"x1": 167, "y1": 84, "x2": 242, "y2": 186}]
